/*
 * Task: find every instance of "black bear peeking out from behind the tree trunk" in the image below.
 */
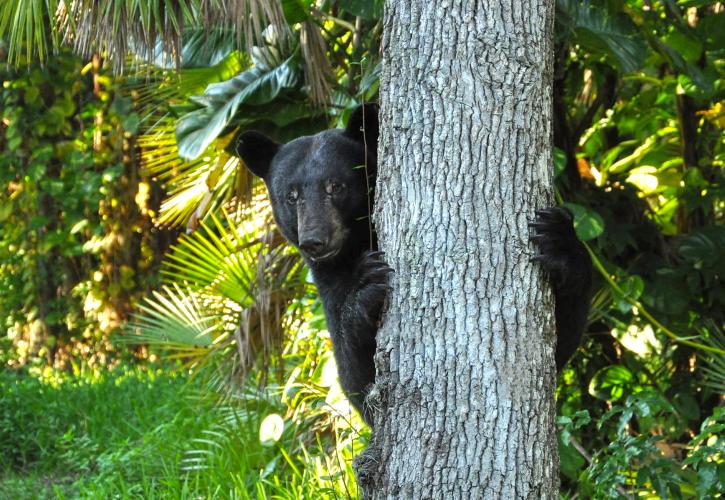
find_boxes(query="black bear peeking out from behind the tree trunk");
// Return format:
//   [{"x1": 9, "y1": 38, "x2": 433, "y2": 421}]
[{"x1": 237, "y1": 104, "x2": 591, "y2": 424}]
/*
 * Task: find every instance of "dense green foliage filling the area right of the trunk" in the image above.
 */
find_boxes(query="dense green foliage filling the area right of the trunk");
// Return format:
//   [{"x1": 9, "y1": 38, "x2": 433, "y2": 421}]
[{"x1": 555, "y1": 0, "x2": 725, "y2": 498}]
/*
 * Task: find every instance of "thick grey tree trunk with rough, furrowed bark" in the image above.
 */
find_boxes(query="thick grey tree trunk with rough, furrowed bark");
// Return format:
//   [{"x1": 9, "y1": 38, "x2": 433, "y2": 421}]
[{"x1": 356, "y1": 0, "x2": 559, "y2": 499}]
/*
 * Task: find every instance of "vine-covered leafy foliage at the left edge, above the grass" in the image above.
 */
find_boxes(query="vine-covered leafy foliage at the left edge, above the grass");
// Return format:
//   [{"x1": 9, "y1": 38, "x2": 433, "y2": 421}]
[{"x1": 0, "y1": 54, "x2": 168, "y2": 362}]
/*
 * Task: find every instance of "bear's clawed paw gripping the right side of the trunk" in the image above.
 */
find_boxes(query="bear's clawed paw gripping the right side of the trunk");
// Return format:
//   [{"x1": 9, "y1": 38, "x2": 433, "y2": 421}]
[{"x1": 529, "y1": 207, "x2": 591, "y2": 288}]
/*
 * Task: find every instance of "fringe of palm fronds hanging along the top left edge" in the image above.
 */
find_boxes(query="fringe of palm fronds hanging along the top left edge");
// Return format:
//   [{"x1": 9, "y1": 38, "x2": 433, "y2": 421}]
[{"x1": 0, "y1": 0, "x2": 291, "y2": 71}]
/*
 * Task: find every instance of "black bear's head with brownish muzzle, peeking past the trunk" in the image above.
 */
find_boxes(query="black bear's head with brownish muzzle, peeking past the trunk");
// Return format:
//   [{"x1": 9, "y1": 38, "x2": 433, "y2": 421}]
[{"x1": 236, "y1": 104, "x2": 378, "y2": 263}]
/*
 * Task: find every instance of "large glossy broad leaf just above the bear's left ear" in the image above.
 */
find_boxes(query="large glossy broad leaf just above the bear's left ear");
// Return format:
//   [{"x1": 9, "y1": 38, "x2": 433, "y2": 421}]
[{"x1": 176, "y1": 58, "x2": 300, "y2": 160}]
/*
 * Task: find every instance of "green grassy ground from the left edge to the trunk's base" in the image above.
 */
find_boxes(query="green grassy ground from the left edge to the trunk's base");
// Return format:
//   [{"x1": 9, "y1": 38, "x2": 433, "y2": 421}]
[{"x1": 0, "y1": 367, "x2": 364, "y2": 499}]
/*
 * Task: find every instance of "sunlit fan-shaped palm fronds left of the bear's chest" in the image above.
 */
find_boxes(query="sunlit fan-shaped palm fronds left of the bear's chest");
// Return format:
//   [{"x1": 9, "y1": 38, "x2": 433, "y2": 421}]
[{"x1": 131, "y1": 209, "x2": 307, "y2": 384}]
